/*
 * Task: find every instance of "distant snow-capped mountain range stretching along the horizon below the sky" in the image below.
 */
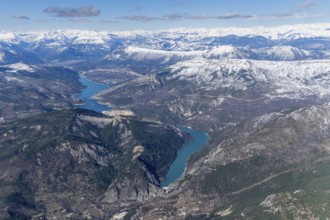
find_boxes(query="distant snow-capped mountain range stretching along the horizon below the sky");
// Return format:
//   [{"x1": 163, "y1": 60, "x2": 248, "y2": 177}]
[{"x1": 0, "y1": 24, "x2": 330, "y2": 64}]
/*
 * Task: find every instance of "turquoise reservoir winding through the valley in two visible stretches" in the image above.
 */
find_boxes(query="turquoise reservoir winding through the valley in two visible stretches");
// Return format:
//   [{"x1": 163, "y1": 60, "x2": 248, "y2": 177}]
[{"x1": 78, "y1": 76, "x2": 208, "y2": 187}]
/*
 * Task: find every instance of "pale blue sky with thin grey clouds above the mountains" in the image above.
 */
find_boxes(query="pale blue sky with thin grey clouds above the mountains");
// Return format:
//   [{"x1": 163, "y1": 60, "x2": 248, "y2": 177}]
[{"x1": 0, "y1": 0, "x2": 330, "y2": 31}]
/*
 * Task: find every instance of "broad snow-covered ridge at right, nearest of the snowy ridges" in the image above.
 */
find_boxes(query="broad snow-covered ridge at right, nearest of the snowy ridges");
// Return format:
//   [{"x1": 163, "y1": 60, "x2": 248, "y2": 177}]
[{"x1": 170, "y1": 58, "x2": 330, "y2": 98}]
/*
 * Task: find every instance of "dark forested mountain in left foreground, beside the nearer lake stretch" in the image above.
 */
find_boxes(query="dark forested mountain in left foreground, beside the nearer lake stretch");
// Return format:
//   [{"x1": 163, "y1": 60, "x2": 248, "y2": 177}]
[{"x1": 0, "y1": 110, "x2": 185, "y2": 218}]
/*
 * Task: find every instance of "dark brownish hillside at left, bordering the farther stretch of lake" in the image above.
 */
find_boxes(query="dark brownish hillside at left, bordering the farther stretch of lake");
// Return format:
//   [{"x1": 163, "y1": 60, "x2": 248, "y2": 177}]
[{"x1": 0, "y1": 63, "x2": 83, "y2": 121}]
